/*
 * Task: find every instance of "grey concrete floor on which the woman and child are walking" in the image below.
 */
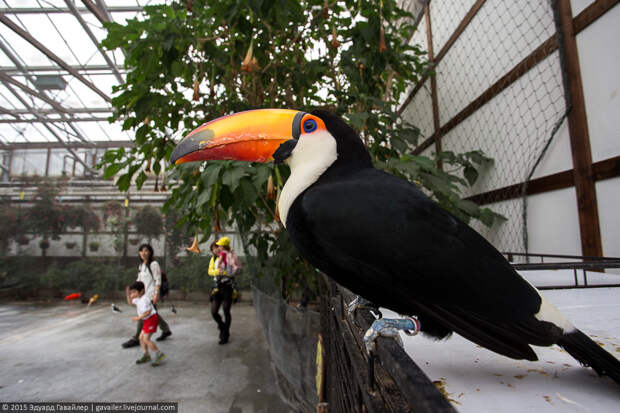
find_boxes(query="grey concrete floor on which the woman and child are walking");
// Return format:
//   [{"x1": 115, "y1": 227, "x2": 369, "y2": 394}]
[{"x1": 0, "y1": 302, "x2": 291, "y2": 413}]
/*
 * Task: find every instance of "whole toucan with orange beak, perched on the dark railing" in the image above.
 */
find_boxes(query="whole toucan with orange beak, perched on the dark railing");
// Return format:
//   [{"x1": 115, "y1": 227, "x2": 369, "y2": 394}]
[{"x1": 171, "y1": 109, "x2": 620, "y2": 384}]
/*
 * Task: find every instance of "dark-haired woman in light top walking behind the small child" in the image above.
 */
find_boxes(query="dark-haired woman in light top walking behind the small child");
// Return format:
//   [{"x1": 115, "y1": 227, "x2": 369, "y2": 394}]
[{"x1": 122, "y1": 244, "x2": 172, "y2": 348}]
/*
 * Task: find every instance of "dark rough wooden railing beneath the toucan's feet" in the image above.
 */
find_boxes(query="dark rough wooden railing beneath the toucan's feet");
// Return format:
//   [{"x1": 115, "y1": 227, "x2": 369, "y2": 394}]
[{"x1": 317, "y1": 277, "x2": 456, "y2": 413}]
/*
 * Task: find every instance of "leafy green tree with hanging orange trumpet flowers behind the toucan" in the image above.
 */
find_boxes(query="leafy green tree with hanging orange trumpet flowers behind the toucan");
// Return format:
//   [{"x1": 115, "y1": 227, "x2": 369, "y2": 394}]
[{"x1": 100, "y1": 0, "x2": 497, "y2": 296}]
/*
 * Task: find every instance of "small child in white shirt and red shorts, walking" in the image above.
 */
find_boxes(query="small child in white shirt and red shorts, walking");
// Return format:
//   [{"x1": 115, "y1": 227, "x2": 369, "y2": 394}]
[{"x1": 125, "y1": 281, "x2": 166, "y2": 367}]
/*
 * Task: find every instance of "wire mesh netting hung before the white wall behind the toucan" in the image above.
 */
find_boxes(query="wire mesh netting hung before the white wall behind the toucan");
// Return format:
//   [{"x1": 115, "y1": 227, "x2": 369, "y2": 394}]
[{"x1": 403, "y1": 0, "x2": 571, "y2": 260}]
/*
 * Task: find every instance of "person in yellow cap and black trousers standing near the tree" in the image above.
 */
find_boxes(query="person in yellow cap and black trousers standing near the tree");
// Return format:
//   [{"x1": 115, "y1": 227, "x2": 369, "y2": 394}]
[{"x1": 209, "y1": 237, "x2": 242, "y2": 344}]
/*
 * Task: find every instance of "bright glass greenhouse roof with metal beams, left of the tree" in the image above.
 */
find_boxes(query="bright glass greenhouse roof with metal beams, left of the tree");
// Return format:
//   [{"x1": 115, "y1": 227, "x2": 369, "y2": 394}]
[{"x1": 0, "y1": 0, "x2": 165, "y2": 145}]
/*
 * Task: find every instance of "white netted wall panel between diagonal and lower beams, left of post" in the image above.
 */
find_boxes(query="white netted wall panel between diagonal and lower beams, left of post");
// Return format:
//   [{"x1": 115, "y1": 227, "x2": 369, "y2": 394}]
[{"x1": 442, "y1": 53, "x2": 572, "y2": 196}]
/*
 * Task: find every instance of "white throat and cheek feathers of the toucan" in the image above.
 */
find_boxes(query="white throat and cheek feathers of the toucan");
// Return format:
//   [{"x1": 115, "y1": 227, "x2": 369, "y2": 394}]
[{"x1": 278, "y1": 131, "x2": 338, "y2": 227}]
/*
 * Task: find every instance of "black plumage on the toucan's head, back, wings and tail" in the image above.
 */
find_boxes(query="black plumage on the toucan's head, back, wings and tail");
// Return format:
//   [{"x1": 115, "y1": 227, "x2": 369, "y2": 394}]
[{"x1": 286, "y1": 111, "x2": 620, "y2": 381}]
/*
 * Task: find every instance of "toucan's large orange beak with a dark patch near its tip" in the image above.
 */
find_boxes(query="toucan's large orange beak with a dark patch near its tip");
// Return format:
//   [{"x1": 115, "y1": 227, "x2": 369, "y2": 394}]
[{"x1": 170, "y1": 109, "x2": 304, "y2": 164}]
